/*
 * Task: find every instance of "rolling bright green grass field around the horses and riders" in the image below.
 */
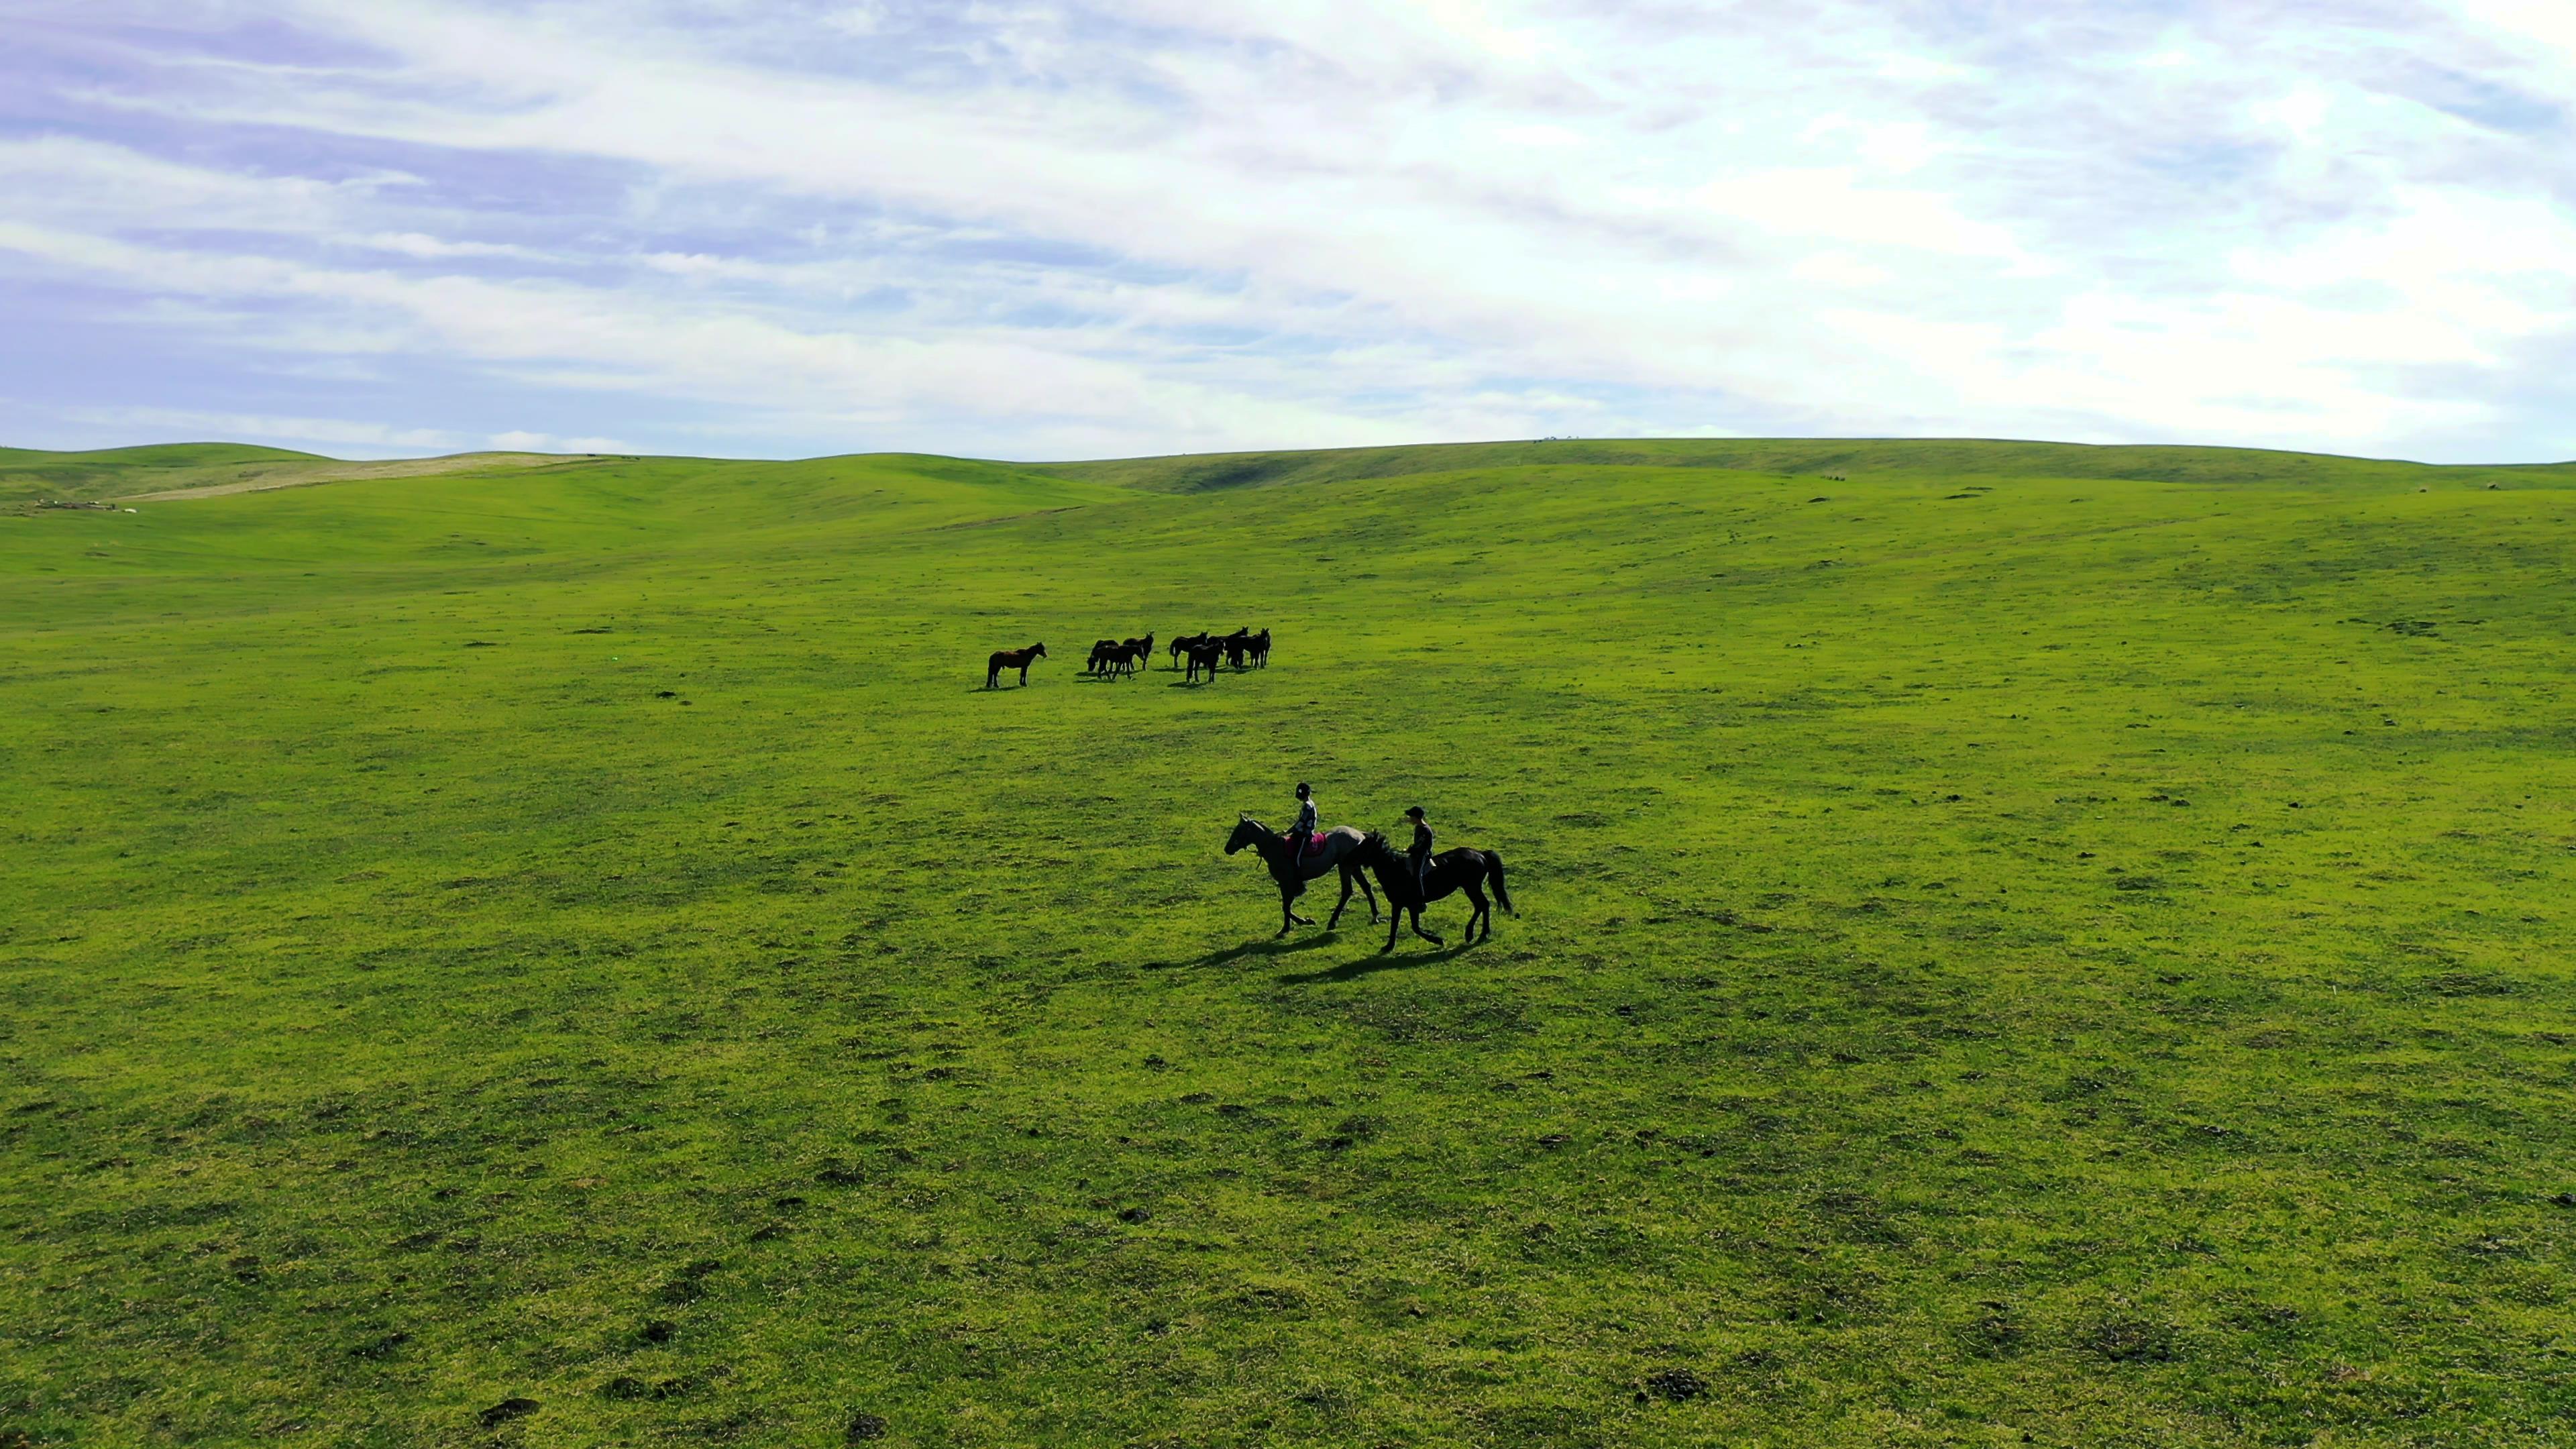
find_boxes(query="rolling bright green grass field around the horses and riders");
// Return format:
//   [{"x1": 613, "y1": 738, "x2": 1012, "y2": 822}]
[{"x1": 0, "y1": 441, "x2": 2576, "y2": 1449}]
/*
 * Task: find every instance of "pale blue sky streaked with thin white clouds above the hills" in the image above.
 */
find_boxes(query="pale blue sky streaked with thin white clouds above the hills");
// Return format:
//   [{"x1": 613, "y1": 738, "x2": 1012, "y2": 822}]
[{"x1": 0, "y1": 0, "x2": 2576, "y2": 462}]
